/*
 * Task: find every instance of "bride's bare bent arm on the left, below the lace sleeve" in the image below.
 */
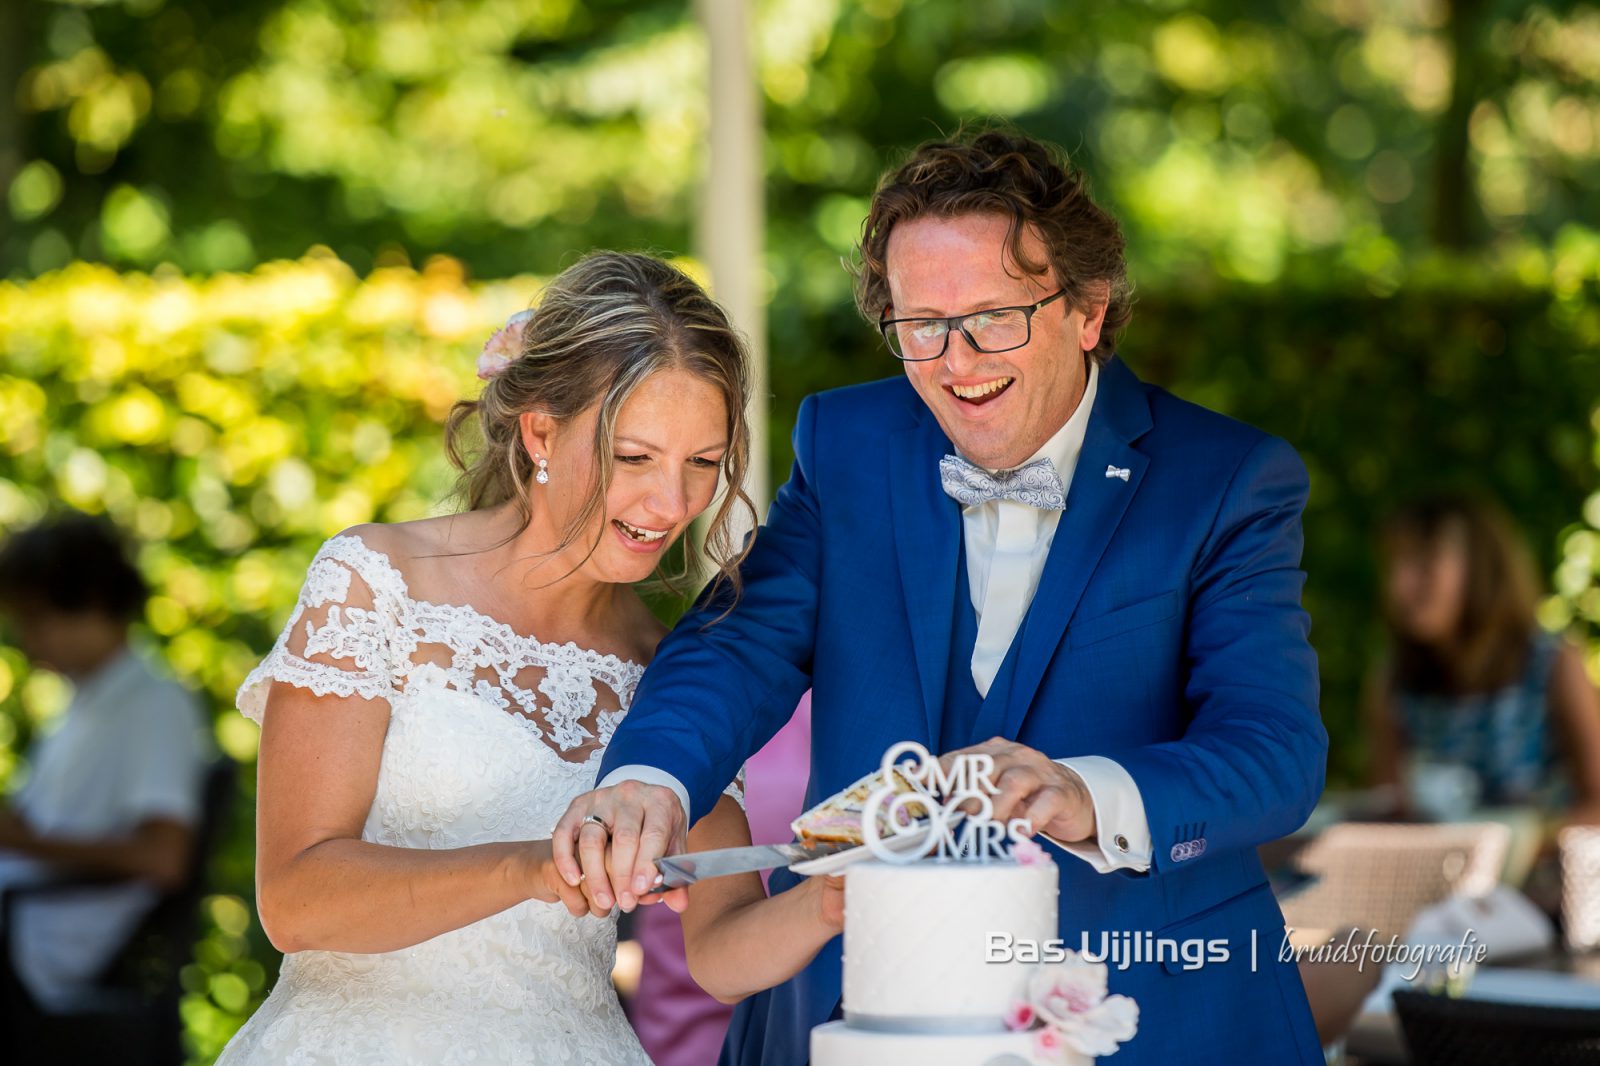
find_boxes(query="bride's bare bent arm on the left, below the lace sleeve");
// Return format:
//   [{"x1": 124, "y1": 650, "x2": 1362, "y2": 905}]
[{"x1": 256, "y1": 683, "x2": 589, "y2": 952}]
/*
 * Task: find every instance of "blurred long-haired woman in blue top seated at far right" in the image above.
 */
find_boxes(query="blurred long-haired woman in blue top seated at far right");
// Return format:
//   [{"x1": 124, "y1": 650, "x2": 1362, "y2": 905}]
[{"x1": 1368, "y1": 496, "x2": 1600, "y2": 821}]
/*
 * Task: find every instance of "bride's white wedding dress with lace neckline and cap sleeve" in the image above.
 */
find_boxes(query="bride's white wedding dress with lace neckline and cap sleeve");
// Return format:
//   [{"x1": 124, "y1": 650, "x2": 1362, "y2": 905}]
[{"x1": 218, "y1": 535, "x2": 742, "y2": 1066}]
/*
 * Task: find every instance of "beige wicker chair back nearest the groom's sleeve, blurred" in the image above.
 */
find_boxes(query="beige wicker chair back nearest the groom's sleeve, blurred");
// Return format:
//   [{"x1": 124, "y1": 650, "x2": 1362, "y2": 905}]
[{"x1": 1283, "y1": 821, "x2": 1510, "y2": 936}]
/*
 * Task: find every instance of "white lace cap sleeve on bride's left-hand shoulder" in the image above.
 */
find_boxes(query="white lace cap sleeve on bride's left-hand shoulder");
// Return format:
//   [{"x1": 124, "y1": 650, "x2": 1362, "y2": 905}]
[{"x1": 237, "y1": 535, "x2": 395, "y2": 723}]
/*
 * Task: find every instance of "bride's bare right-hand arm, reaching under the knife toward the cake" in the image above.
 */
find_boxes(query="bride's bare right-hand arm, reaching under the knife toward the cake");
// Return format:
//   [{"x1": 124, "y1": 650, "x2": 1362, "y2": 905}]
[{"x1": 683, "y1": 795, "x2": 845, "y2": 1004}]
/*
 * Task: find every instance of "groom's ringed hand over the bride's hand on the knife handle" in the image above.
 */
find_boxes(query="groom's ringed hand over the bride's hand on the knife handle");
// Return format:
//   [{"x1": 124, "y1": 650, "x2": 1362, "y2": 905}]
[{"x1": 550, "y1": 781, "x2": 688, "y2": 912}]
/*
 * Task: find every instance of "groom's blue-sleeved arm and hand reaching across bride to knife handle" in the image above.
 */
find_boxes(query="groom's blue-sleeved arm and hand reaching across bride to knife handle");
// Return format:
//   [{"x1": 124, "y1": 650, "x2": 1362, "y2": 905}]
[{"x1": 552, "y1": 397, "x2": 822, "y2": 906}]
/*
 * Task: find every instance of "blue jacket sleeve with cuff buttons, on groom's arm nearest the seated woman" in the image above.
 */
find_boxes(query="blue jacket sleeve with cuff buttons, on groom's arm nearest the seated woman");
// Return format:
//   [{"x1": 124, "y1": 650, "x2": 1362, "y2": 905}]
[{"x1": 1106, "y1": 437, "x2": 1328, "y2": 874}]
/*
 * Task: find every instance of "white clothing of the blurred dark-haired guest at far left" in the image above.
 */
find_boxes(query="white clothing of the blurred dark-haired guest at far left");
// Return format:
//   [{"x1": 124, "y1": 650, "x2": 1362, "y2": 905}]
[{"x1": 0, "y1": 650, "x2": 210, "y2": 1010}]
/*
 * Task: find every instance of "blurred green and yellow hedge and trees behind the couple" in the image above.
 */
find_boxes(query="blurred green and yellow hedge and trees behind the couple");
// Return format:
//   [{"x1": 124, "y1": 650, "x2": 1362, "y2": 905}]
[{"x1": 0, "y1": 0, "x2": 1600, "y2": 1061}]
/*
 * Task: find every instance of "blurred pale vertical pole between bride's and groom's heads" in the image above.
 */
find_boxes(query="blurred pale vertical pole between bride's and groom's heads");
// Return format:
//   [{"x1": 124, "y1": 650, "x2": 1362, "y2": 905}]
[{"x1": 694, "y1": 0, "x2": 771, "y2": 517}]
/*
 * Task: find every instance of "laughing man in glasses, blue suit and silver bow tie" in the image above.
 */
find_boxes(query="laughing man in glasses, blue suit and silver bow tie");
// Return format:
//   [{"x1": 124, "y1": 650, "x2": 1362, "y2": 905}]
[{"x1": 554, "y1": 131, "x2": 1326, "y2": 1066}]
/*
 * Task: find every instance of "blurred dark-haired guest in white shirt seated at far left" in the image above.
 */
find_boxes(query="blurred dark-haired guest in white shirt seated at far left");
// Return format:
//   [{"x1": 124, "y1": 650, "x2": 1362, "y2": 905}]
[{"x1": 0, "y1": 515, "x2": 206, "y2": 1010}]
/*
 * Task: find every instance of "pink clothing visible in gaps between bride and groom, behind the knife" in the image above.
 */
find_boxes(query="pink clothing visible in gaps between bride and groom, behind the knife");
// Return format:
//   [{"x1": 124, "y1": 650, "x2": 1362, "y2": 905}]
[{"x1": 629, "y1": 693, "x2": 811, "y2": 1066}]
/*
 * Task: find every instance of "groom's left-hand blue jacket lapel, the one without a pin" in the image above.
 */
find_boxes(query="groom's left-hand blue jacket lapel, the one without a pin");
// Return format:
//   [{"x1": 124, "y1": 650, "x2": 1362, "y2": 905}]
[{"x1": 890, "y1": 415, "x2": 965, "y2": 751}]
